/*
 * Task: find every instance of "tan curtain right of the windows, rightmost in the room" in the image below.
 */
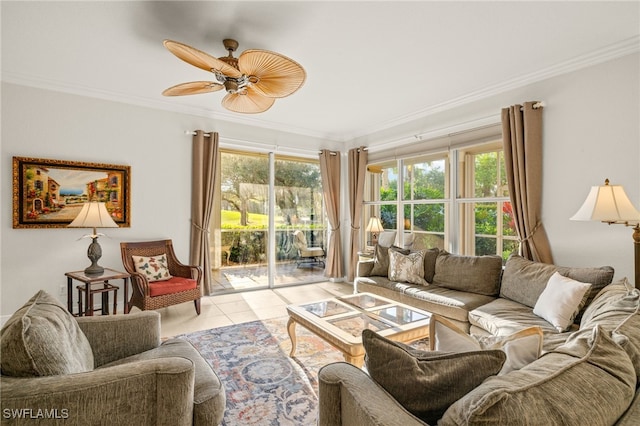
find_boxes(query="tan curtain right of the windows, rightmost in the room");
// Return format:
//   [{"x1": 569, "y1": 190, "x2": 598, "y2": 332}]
[{"x1": 502, "y1": 102, "x2": 553, "y2": 263}]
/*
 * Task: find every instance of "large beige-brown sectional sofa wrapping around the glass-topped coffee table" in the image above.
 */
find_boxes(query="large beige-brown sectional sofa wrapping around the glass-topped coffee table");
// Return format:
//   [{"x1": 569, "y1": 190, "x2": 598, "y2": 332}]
[{"x1": 319, "y1": 252, "x2": 640, "y2": 426}]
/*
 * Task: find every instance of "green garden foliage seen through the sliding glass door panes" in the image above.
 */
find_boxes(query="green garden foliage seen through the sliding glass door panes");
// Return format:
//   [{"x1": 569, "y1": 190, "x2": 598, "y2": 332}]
[{"x1": 221, "y1": 153, "x2": 324, "y2": 264}]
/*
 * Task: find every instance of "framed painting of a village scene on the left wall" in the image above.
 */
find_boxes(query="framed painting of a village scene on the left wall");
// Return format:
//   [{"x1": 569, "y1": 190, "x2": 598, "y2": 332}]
[{"x1": 13, "y1": 157, "x2": 131, "y2": 228}]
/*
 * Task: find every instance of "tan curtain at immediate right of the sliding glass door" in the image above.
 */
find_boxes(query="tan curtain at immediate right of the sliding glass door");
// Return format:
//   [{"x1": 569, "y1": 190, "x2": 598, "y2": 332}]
[{"x1": 320, "y1": 149, "x2": 344, "y2": 278}]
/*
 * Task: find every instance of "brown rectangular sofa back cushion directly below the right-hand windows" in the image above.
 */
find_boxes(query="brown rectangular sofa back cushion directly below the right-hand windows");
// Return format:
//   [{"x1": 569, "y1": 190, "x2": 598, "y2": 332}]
[{"x1": 433, "y1": 252, "x2": 502, "y2": 296}]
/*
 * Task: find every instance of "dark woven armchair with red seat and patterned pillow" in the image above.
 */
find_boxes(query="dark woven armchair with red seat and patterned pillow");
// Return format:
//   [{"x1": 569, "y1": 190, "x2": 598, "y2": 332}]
[{"x1": 120, "y1": 240, "x2": 202, "y2": 315}]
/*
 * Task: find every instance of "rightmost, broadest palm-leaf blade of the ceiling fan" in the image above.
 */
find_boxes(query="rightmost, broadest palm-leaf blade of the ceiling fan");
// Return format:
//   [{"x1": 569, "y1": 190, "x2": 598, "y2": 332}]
[{"x1": 238, "y1": 49, "x2": 307, "y2": 98}]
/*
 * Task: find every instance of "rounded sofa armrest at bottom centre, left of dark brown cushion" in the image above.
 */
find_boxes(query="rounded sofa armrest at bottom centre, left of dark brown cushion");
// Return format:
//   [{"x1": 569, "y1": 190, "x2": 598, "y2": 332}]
[{"x1": 318, "y1": 362, "x2": 426, "y2": 426}]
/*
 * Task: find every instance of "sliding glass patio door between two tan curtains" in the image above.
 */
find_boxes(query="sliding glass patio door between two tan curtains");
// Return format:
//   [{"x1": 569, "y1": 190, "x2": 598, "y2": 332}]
[{"x1": 210, "y1": 150, "x2": 326, "y2": 290}]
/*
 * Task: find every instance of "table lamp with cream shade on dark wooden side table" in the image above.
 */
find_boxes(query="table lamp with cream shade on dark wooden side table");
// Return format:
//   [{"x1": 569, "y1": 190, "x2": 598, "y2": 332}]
[{"x1": 68, "y1": 201, "x2": 118, "y2": 275}]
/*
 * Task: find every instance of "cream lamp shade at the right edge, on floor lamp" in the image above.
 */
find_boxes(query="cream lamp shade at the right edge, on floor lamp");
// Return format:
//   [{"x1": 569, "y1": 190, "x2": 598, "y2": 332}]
[{"x1": 570, "y1": 181, "x2": 640, "y2": 223}]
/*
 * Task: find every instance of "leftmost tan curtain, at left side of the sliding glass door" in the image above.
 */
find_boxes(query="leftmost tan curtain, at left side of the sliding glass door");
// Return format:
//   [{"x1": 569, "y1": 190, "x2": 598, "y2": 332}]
[{"x1": 190, "y1": 130, "x2": 219, "y2": 295}]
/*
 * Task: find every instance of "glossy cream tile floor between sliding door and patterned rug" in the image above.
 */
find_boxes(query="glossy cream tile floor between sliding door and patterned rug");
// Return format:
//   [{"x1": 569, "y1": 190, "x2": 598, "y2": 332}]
[{"x1": 142, "y1": 282, "x2": 353, "y2": 337}]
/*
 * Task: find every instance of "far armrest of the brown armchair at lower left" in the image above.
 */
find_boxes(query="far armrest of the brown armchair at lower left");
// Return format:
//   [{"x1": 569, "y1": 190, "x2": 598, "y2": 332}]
[{"x1": 76, "y1": 311, "x2": 160, "y2": 367}]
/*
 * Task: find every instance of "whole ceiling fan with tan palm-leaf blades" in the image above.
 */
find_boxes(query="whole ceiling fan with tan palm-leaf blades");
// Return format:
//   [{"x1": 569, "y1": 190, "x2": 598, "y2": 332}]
[{"x1": 162, "y1": 39, "x2": 307, "y2": 114}]
